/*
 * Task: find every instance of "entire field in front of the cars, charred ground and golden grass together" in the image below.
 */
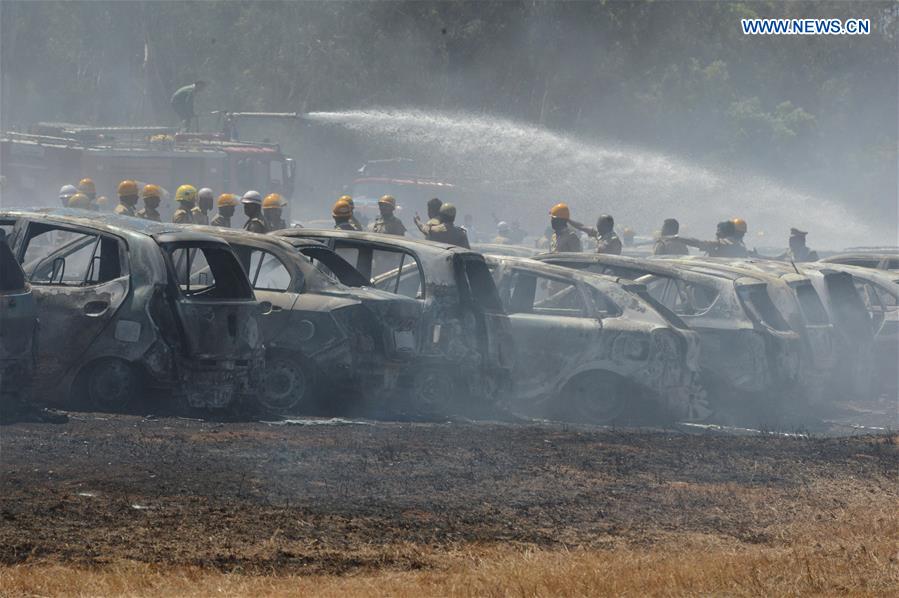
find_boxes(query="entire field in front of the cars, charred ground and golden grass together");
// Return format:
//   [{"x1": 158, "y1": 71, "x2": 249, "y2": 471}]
[{"x1": 0, "y1": 414, "x2": 899, "y2": 598}]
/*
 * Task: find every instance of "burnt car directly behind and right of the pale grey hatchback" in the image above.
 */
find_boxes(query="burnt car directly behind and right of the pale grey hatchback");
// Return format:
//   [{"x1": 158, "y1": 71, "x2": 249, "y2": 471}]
[{"x1": 536, "y1": 253, "x2": 802, "y2": 409}]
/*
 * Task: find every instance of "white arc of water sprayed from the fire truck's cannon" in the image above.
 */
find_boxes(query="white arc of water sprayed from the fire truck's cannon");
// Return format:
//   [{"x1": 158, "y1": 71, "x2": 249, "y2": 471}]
[{"x1": 309, "y1": 109, "x2": 873, "y2": 247}]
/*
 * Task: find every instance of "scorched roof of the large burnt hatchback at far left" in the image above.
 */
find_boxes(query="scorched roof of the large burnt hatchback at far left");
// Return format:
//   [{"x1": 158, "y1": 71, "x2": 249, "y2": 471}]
[{"x1": 0, "y1": 208, "x2": 232, "y2": 244}]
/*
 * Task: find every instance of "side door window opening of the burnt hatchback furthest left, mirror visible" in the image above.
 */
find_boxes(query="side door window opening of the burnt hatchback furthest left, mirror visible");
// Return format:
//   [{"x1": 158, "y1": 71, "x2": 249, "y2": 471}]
[{"x1": 23, "y1": 225, "x2": 123, "y2": 286}]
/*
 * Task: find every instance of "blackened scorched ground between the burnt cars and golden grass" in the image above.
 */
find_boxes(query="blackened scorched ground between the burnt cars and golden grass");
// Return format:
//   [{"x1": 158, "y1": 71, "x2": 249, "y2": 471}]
[{"x1": 0, "y1": 413, "x2": 899, "y2": 573}]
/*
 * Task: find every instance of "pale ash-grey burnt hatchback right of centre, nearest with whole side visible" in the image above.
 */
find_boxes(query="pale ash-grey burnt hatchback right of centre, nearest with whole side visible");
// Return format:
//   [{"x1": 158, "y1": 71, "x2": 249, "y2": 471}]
[{"x1": 487, "y1": 255, "x2": 711, "y2": 424}]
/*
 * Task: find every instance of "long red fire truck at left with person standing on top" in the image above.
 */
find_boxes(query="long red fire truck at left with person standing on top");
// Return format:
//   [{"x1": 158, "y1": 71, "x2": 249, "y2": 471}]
[{"x1": 0, "y1": 123, "x2": 296, "y2": 216}]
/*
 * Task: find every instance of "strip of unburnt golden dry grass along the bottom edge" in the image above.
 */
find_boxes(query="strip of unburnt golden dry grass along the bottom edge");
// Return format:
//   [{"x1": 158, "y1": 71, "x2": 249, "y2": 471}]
[{"x1": 0, "y1": 501, "x2": 899, "y2": 598}]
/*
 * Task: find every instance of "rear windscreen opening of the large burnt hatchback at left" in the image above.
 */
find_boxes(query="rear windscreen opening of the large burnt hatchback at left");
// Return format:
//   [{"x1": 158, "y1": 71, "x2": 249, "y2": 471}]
[{"x1": 169, "y1": 245, "x2": 253, "y2": 299}]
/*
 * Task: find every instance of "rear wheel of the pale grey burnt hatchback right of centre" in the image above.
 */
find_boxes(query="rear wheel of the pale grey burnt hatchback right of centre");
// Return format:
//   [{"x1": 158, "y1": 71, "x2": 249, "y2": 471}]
[{"x1": 553, "y1": 372, "x2": 628, "y2": 424}]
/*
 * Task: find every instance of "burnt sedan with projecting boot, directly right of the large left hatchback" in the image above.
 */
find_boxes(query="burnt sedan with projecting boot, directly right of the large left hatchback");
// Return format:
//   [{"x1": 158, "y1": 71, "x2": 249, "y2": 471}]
[{"x1": 192, "y1": 226, "x2": 420, "y2": 414}]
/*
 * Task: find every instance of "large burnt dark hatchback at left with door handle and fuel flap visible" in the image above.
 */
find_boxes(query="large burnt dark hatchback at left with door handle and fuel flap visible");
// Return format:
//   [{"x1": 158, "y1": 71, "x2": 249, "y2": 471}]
[{"x1": 0, "y1": 209, "x2": 263, "y2": 411}]
